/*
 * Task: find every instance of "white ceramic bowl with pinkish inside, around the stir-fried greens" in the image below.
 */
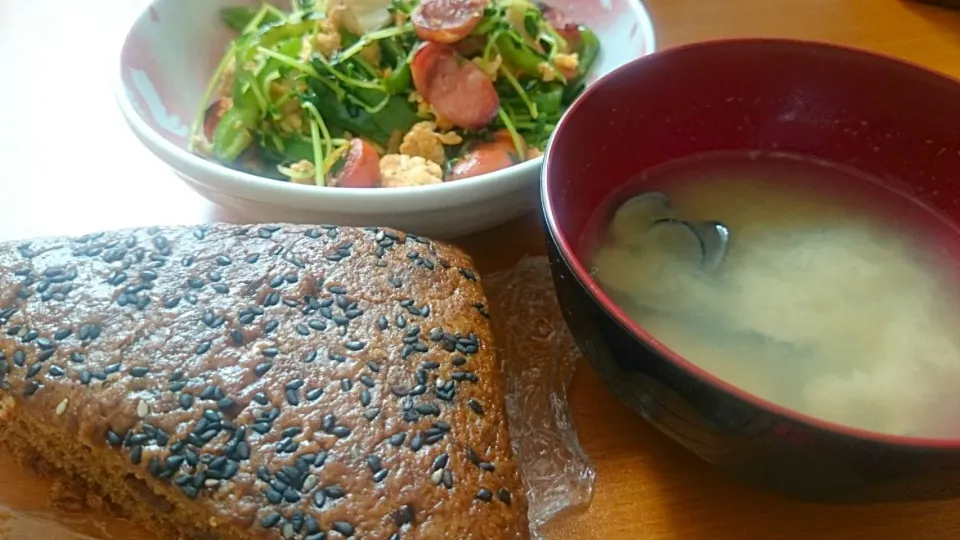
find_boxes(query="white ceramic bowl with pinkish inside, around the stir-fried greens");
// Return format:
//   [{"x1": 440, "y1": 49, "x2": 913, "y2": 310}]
[{"x1": 110, "y1": 0, "x2": 655, "y2": 237}]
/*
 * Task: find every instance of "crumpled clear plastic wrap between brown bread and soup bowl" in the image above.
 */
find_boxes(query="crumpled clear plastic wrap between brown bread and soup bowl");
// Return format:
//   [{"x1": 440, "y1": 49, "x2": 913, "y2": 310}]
[{"x1": 484, "y1": 257, "x2": 596, "y2": 538}]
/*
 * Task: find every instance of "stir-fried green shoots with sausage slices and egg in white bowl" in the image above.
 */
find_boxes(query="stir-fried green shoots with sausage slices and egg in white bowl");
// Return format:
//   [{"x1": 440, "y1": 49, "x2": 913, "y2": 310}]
[{"x1": 190, "y1": 0, "x2": 599, "y2": 187}]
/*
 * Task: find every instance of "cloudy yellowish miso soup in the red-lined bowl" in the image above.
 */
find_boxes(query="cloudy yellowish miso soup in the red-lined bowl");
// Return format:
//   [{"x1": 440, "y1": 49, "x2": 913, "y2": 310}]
[{"x1": 588, "y1": 152, "x2": 960, "y2": 437}]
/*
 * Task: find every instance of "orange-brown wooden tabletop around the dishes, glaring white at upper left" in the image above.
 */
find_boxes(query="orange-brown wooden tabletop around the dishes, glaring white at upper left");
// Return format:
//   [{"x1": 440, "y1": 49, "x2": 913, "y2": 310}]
[{"x1": 0, "y1": 0, "x2": 960, "y2": 540}]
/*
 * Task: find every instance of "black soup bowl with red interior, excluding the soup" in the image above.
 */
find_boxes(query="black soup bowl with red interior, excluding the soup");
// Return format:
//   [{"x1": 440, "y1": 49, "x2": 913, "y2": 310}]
[{"x1": 541, "y1": 39, "x2": 960, "y2": 500}]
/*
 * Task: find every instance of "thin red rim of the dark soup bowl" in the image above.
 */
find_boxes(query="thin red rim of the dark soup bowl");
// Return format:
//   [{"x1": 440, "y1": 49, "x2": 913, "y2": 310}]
[{"x1": 540, "y1": 37, "x2": 960, "y2": 450}]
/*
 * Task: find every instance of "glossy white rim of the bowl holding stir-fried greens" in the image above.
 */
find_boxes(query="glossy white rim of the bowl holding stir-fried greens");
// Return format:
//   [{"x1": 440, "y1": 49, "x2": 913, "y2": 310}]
[{"x1": 112, "y1": 0, "x2": 657, "y2": 210}]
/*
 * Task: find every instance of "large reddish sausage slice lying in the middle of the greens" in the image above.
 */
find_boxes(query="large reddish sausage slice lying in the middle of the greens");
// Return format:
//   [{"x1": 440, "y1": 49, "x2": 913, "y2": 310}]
[{"x1": 411, "y1": 43, "x2": 500, "y2": 129}]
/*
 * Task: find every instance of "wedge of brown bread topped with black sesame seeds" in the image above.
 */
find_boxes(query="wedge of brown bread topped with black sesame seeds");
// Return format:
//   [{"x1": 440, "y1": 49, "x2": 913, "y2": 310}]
[{"x1": 0, "y1": 225, "x2": 528, "y2": 540}]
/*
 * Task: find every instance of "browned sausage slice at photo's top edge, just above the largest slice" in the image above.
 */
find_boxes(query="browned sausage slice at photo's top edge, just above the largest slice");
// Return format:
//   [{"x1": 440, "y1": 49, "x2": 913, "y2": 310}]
[{"x1": 410, "y1": 0, "x2": 487, "y2": 43}]
